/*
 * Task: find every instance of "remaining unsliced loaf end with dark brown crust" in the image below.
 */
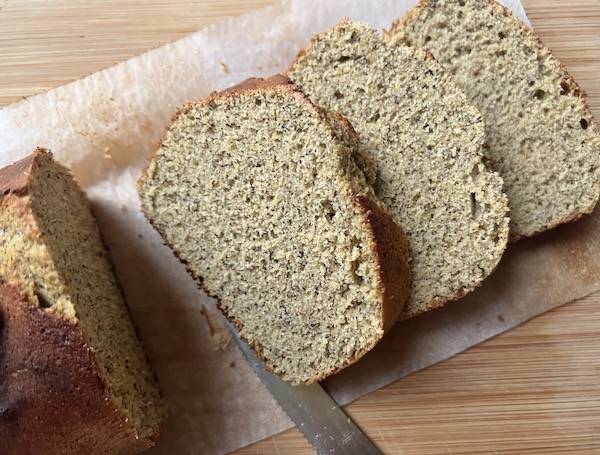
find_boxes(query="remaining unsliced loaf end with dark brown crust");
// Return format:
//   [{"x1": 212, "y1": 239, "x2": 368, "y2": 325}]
[{"x1": 0, "y1": 149, "x2": 166, "y2": 455}]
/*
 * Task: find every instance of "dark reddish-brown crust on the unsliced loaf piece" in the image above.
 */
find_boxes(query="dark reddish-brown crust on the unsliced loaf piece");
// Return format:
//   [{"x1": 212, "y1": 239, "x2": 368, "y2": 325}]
[{"x1": 0, "y1": 283, "x2": 145, "y2": 455}]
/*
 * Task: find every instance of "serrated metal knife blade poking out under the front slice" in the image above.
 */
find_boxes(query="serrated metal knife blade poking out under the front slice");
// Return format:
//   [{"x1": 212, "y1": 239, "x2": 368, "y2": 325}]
[{"x1": 227, "y1": 321, "x2": 381, "y2": 455}]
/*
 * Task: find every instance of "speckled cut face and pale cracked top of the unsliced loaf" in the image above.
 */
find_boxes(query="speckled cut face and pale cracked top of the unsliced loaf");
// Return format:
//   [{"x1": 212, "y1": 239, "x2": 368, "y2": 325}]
[{"x1": 0, "y1": 149, "x2": 166, "y2": 446}]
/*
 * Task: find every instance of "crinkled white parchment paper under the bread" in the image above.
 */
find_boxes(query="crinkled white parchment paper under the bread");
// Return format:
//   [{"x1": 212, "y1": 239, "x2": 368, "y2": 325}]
[{"x1": 5, "y1": 0, "x2": 600, "y2": 455}]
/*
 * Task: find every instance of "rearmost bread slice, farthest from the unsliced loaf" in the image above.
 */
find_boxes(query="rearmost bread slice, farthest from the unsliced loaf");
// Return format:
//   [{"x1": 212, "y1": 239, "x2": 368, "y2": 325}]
[{"x1": 390, "y1": 0, "x2": 600, "y2": 239}]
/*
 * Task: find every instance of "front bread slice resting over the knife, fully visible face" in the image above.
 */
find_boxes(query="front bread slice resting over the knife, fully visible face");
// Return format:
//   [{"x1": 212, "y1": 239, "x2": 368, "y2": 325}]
[{"x1": 139, "y1": 76, "x2": 409, "y2": 383}]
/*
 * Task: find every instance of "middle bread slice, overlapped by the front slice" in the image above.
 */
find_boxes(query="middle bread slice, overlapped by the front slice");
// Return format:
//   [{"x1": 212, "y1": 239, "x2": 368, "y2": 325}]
[{"x1": 289, "y1": 21, "x2": 508, "y2": 318}]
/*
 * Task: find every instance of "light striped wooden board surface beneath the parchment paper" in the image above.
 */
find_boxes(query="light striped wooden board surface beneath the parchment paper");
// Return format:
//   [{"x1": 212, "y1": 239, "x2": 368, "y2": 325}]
[{"x1": 0, "y1": 0, "x2": 600, "y2": 455}]
